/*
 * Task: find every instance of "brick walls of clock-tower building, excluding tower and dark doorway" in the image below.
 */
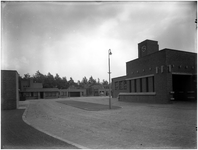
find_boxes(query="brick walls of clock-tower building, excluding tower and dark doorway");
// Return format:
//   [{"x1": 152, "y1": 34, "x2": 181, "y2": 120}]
[{"x1": 112, "y1": 49, "x2": 197, "y2": 103}]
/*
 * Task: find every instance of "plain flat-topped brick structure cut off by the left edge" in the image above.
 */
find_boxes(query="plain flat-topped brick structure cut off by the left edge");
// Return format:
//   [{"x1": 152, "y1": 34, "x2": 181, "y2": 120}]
[{"x1": 1, "y1": 70, "x2": 19, "y2": 110}]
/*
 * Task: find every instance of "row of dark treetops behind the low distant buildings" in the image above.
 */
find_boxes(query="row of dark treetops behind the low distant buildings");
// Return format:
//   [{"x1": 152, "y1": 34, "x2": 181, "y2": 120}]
[{"x1": 19, "y1": 71, "x2": 109, "y2": 89}]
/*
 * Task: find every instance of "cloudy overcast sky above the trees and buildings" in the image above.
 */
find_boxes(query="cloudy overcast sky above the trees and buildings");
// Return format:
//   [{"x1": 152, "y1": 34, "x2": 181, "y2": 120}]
[{"x1": 1, "y1": 2, "x2": 197, "y2": 82}]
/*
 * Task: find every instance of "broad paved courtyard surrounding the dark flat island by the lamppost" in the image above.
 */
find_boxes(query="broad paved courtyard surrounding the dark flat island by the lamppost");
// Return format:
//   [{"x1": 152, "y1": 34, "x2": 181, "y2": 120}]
[{"x1": 21, "y1": 97, "x2": 197, "y2": 149}]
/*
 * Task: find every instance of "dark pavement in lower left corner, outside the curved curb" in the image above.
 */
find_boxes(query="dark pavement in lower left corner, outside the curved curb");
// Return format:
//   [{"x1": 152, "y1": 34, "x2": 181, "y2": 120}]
[{"x1": 1, "y1": 109, "x2": 78, "y2": 149}]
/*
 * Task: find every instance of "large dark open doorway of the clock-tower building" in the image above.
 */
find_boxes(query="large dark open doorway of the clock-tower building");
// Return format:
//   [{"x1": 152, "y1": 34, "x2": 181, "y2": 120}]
[{"x1": 173, "y1": 75, "x2": 197, "y2": 101}]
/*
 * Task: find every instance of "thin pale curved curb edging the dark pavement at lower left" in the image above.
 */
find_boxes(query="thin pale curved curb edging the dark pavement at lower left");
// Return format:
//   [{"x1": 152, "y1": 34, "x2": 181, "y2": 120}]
[{"x1": 22, "y1": 103, "x2": 89, "y2": 149}]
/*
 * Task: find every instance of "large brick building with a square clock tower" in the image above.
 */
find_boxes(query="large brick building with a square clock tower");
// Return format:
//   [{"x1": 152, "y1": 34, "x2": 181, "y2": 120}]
[{"x1": 112, "y1": 40, "x2": 197, "y2": 103}]
